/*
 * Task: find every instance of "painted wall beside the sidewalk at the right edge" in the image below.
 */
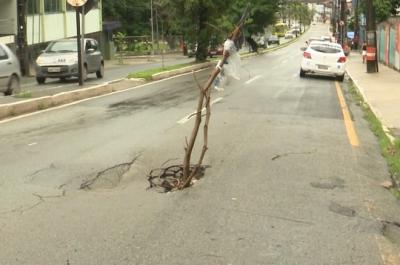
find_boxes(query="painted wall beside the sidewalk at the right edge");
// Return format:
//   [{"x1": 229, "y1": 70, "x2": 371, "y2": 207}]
[{"x1": 377, "y1": 17, "x2": 400, "y2": 71}]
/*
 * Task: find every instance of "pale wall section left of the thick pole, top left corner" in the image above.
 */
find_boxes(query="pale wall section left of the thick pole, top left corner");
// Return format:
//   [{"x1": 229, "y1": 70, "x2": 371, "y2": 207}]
[{"x1": 0, "y1": 0, "x2": 17, "y2": 35}]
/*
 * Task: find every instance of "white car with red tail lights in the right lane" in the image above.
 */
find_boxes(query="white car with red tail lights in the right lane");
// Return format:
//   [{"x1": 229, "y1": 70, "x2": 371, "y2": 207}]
[{"x1": 300, "y1": 41, "x2": 347, "y2": 82}]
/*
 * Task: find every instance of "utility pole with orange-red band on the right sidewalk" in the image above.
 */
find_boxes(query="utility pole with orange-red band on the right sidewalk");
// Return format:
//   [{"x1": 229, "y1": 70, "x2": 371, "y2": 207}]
[{"x1": 366, "y1": 0, "x2": 379, "y2": 73}]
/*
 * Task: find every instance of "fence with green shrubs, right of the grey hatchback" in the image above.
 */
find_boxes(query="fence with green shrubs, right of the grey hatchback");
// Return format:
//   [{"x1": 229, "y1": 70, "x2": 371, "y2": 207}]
[{"x1": 113, "y1": 35, "x2": 183, "y2": 57}]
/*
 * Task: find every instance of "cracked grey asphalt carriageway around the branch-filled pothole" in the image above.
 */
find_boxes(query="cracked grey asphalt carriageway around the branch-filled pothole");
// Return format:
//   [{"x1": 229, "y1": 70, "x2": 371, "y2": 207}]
[{"x1": 0, "y1": 25, "x2": 400, "y2": 265}]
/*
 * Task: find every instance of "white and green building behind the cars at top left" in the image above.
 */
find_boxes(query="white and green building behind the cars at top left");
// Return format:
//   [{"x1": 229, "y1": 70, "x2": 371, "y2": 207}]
[{"x1": 0, "y1": 0, "x2": 102, "y2": 73}]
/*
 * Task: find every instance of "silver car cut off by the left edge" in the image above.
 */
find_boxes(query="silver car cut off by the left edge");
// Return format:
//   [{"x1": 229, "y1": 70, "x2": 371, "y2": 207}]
[{"x1": 0, "y1": 43, "x2": 21, "y2": 96}]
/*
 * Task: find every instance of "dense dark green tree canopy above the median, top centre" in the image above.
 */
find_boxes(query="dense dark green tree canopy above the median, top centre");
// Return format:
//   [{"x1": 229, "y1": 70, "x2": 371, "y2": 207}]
[{"x1": 103, "y1": 0, "x2": 279, "y2": 61}]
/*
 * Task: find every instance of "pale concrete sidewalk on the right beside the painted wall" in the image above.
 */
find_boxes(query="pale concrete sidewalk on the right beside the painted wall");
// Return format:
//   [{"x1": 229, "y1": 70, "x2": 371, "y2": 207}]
[{"x1": 347, "y1": 52, "x2": 400, "y2": 137}]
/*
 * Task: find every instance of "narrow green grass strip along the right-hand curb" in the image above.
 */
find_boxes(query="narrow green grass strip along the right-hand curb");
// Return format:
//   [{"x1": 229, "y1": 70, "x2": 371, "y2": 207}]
[{"x1": 348, "y1": 83, "x2": 400, "y2": 198}]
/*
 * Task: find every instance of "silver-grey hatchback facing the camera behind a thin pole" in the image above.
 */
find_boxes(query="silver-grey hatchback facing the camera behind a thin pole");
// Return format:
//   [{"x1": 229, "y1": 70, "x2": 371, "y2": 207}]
[{"x1": 36, "y1": 39, "x2": 104, "y2": 84}]
